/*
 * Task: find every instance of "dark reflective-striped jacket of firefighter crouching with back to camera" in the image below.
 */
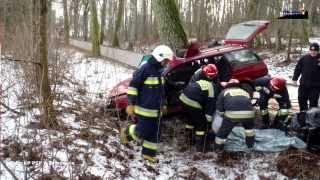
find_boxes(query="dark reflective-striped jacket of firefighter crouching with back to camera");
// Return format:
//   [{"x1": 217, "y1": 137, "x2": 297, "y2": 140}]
[{"x1": 217, "y1": 87, "x2": 255, "y2": 121}]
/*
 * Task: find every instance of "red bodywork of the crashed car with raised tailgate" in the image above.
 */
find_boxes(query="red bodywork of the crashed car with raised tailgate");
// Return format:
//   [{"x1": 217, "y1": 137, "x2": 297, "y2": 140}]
[{"x1": 108, "y1": 21, "x2": 269, "y2": 112}]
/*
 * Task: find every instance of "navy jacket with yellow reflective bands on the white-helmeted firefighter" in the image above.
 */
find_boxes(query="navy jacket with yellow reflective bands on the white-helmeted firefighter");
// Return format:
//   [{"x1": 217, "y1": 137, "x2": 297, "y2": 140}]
[{"x1": 127, "y1": 57, "x2": 165, "y2": 118}]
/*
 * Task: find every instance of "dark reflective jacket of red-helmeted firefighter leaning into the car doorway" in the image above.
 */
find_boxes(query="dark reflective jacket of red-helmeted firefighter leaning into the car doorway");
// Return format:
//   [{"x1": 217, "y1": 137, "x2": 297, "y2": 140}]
[{"x1": 179, "y1": 80, "x2": 215, "y2": 121}]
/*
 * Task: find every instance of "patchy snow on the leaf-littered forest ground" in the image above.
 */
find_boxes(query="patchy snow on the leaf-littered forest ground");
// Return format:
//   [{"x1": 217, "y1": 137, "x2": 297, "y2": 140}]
[{"x1": 0, "y1": 47, "x2": 316, "y2": 180}]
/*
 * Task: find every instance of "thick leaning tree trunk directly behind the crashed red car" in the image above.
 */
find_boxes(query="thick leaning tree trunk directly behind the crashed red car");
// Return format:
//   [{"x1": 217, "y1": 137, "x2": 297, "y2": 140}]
[{"x1": 153, "y1": 0, "x2": 187, "y2": 49}]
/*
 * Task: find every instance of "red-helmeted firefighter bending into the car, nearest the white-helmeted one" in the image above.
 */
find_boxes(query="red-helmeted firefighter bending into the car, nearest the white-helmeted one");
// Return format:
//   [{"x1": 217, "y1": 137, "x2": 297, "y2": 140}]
[{"x1": 179, "y1": 64, "x2": 218, "y2": 152}]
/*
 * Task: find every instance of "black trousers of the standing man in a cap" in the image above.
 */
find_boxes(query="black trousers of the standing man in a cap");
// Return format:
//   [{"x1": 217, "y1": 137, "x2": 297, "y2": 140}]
[{"x1": 298, "y1": 85, "x2": 320, "y2": 111}]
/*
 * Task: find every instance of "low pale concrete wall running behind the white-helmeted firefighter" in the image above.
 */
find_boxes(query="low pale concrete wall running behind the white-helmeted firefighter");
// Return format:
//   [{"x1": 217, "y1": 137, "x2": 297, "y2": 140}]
[{"x1": 70, "y1": 39, "x2": 143, "y2": 67}]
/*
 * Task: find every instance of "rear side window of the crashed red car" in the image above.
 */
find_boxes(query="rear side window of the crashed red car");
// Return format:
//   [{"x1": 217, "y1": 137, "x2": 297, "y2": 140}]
[{"x1": 225, "y1": 49, "x2": 259, "y2": 65}]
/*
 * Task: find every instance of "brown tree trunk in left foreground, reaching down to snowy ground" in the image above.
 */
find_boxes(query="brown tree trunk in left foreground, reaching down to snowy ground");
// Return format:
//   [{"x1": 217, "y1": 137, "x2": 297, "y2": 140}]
[{"x1": 39, "y1": 0, "x2": 59, "y2": 128}]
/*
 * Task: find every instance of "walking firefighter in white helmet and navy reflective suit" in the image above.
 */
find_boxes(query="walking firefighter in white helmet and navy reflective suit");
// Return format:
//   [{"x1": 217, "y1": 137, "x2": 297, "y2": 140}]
[{"x1": 120, "y1": 45, "x2": 173, "y2": 162}]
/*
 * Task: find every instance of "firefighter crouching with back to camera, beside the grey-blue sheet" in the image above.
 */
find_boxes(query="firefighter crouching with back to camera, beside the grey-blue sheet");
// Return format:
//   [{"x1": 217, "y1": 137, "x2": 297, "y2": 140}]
[{"x1": 214, "y1": 79, "x2": 255, "y2": 152}]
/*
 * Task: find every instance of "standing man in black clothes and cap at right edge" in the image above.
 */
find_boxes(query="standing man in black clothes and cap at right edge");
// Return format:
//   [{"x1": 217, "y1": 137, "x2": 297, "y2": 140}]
[{"x1": 292, "y1": 43, "x2": 320, "y2": 126}]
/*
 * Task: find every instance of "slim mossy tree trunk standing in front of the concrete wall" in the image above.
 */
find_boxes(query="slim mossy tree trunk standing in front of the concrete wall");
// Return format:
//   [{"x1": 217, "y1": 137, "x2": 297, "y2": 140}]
[{"x1": 90, "y1": 0, "x2": 100, "y2": 56}]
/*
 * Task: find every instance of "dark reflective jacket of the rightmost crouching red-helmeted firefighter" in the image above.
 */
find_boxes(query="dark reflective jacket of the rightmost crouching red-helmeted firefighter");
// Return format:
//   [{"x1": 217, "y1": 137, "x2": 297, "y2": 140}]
[{"x1": 255, "y1": 76, "x2": 291, "y2": 115}]
